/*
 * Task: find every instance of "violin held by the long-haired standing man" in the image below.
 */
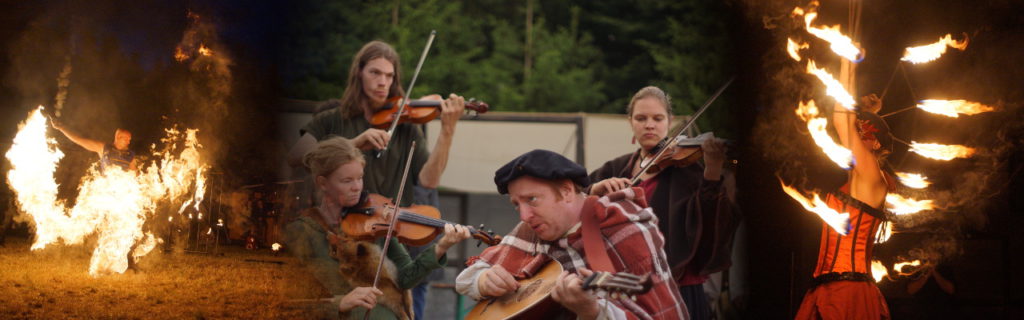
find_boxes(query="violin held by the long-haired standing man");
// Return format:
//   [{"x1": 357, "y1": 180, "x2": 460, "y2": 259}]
[{"x1": 370, "y1": 95, "x2": 490, "y2": 129}]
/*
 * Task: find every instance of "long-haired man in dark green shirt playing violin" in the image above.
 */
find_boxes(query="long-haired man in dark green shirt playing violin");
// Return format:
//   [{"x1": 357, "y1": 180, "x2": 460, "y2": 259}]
[{"x1": 289, "y1": 41, "x2": 465, "y2": 206}]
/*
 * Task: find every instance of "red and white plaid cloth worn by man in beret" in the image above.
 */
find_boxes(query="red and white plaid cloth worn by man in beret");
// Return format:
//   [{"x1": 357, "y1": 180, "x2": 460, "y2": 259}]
[{"x1": 466, "y1": 188, "x2": 687, "y2": 319}]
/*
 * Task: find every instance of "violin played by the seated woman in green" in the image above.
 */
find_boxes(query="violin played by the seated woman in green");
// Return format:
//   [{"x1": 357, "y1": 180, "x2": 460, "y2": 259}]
[{"x1": 341, "y1": 194, "x2": 502, "y2": 246}]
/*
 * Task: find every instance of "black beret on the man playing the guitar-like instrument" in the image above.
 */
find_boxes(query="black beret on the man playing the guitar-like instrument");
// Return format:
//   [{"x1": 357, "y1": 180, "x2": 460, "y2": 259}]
[{"x1": 495, "y1": 149, "x2": 590, "y2": 195}]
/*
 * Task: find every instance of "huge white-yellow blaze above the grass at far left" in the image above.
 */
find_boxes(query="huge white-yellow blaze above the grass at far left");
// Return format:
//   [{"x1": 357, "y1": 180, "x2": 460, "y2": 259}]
[{"x1": 6, "y1": 107, "x2": 205, "y2": 277}]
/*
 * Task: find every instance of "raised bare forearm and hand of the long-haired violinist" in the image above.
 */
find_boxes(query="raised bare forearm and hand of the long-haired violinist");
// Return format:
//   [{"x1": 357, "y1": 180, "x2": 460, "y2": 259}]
[{"x1": 420, "y1": 93, "x2": 466, "y2": 189}]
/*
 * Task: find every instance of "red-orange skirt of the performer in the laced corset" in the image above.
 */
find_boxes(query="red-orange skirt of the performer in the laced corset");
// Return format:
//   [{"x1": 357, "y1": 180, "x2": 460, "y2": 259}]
[{"x1": 797, "y1": 281, "x2": 890, "y2": 319}]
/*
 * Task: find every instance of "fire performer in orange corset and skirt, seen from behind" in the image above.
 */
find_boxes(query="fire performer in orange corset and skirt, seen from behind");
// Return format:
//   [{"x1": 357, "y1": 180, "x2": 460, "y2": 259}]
[{"x1": 797, "y1": 94, "x2": 895, "y2": 319}]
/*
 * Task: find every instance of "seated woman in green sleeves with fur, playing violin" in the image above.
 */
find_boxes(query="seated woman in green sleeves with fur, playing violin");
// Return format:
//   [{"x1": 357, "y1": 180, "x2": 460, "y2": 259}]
[{"x1": 286, "y1": 137, "x2": 469, "y2": 319}]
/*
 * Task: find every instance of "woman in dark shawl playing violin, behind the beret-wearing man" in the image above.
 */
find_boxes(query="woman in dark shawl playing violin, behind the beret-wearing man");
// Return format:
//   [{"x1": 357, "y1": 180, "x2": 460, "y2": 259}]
[{"x1": 590, "y1": 86, "x2": 739, "y2": 319}]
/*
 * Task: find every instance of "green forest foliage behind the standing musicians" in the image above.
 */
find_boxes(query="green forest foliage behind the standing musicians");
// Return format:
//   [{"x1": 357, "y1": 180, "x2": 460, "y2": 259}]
[{"x1": 284, "y1": 0, "x2": 732, "y2": 136}]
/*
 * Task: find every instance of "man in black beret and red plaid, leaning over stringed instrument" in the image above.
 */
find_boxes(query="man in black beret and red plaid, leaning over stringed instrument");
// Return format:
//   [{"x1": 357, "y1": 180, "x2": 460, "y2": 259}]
[{"x1": 456, "y1": 150, "x2": 686, "y2": 319}]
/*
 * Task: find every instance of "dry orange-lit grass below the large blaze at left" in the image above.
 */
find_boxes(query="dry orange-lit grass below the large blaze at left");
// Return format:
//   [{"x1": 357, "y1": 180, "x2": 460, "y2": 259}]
[{"x1": 0, "y1": 238, "x2": 331, "y2": 319}]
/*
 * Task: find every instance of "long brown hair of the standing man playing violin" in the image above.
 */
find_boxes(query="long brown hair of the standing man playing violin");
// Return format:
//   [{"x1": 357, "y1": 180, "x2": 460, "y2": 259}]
[{"x1": 341, "y1": 40, "x2": 403, "y2": 119}]
